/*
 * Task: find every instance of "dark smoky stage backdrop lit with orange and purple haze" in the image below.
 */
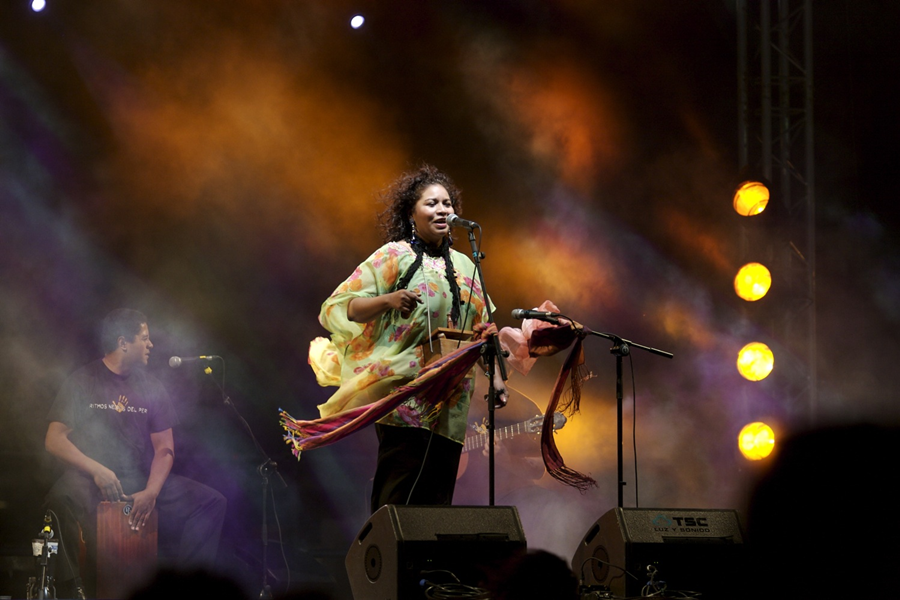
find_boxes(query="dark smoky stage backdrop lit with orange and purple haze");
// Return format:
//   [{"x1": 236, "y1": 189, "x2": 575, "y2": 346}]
[{"x1": 0, "y1": 0, "x2": 900, "y2": 594}]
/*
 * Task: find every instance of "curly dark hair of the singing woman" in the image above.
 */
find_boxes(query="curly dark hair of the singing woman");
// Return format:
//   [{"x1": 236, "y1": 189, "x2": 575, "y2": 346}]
[{"x1": 378, "y1": 164, "x2": 462, "y2": 242}]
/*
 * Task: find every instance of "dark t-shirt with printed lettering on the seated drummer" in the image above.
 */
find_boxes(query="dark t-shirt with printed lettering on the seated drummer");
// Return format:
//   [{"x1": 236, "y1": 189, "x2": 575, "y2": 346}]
[{"x1": 47, "y1": 360, "x2": 178, "y2": 479}]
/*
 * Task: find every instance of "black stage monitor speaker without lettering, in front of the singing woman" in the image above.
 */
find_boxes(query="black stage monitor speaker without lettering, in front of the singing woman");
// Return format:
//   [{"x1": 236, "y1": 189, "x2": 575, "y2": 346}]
[{"x1": 345, "y1": 504, "x2": 526, "y2": 600}]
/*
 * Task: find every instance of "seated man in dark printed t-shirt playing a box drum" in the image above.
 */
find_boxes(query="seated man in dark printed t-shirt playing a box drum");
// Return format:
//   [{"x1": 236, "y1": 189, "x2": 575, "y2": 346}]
[{"x1": 45, "y1": 309, "x2": 226, "y2": 596}]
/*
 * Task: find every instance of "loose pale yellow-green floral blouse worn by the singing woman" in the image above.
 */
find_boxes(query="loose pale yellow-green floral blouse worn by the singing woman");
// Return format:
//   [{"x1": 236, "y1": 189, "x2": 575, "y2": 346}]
[{"x1": 309, "y1": 242, "x2": 488, "y2": 442}]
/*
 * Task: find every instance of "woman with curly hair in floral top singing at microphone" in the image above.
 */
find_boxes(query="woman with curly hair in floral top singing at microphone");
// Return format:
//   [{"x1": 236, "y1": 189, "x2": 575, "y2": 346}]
[{"x1": 310, "y1": 165, "x2": 506, "y2": 512}]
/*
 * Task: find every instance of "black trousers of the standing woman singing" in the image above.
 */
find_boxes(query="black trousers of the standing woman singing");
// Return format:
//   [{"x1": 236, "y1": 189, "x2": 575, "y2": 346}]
[{"x1": 371, "y1": 423, "x2": 462, "y2": 513}]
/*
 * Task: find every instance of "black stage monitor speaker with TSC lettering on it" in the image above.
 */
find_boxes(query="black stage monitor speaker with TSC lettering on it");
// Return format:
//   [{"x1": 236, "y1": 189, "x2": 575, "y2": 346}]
[{"x1": 572, "y1": 508, "x2": 747, "y2": 600}]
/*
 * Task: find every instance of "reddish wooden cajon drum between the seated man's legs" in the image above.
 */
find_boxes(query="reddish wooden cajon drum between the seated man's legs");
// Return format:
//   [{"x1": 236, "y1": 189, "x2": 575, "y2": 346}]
[{"x1": 97, "y1": 502, "x2": 159, "y2": 598}]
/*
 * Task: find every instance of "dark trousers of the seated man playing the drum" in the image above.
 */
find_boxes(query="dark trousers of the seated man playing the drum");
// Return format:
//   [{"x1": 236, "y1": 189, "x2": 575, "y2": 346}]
[{"x1": 45, "y1": 469, "x2": 226, "y2": 589}]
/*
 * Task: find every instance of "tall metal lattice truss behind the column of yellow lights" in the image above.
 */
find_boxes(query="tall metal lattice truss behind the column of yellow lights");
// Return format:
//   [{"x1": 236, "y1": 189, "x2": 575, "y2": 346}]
[{"x1": 737, "y1": 0, "x2": 818, "y2": 422}]
